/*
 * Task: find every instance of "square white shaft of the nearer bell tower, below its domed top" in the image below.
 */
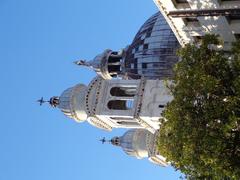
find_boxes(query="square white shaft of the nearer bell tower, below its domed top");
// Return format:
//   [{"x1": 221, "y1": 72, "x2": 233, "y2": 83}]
[{"x1": 92, "y1": 78, "x2": 172, "y2": 133}]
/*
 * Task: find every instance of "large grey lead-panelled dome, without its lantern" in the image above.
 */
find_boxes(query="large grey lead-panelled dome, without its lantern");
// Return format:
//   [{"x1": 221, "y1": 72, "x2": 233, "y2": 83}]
[{"x1": 123, "y1": 12, "x2": 180, "y2": 79}]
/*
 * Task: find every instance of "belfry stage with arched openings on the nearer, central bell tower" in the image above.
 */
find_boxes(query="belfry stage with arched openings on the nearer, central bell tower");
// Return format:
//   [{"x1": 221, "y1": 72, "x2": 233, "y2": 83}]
[{"x1": 96, "y1": 79, "x2": 143, "y2": 128}]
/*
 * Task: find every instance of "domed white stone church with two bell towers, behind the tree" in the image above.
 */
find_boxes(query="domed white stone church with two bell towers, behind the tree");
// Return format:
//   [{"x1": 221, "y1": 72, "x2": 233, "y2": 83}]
[{"x1": 40, "y1": 12, "x2": 180, "y2": 166}]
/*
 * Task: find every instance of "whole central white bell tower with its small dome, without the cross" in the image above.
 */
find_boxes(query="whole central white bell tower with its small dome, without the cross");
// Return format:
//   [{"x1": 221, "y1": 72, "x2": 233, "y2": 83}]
[{"x1": 55, "y1": 76, "x2": 172, "y2": 133}]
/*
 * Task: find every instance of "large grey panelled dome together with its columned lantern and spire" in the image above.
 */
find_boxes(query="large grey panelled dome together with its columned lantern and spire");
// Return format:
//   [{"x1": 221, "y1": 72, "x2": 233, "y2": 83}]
[{"x1": 75, "y1": 12, "x2": 180, "y2": 79}]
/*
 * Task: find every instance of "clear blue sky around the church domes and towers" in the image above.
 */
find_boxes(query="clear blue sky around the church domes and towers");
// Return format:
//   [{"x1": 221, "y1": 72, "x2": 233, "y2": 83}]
[{"x1": 0, "y1": 0, "x2": 180, "y2": 180}]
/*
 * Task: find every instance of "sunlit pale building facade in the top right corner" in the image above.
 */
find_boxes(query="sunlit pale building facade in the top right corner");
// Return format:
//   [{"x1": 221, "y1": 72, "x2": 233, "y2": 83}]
[{"x1": 154, "y1": 0, "x2": 240, "y2": 50}]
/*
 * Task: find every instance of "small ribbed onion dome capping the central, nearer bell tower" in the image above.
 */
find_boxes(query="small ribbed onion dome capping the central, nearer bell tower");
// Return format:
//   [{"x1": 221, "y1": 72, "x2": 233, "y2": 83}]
[{"x1": 58, "y1": 84, "x2": 87, "y2": 122}]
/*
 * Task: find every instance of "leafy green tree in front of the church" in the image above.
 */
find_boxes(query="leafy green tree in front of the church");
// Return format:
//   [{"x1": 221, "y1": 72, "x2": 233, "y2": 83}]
[{"x1": 158, "y1": 35, "x2": 240, "y2": 179}]
